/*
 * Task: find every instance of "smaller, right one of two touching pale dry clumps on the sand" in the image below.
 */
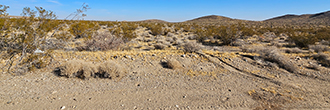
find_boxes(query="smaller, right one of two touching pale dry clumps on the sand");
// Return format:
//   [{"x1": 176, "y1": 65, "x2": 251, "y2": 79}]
[{"x1": 97, "y1": 61, "x2": 127, "y2": 79}]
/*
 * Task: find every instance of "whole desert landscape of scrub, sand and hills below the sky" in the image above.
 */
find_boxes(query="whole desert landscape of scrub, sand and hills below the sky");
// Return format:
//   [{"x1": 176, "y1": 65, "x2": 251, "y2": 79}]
[{"x1": 0, "y1": 5, "x2": 330, "y2": 109}]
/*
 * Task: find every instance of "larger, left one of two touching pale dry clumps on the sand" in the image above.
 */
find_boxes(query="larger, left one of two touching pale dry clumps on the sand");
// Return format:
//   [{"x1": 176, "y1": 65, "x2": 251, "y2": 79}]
[{"x1": 58, "y1": 60, "x2": 97, "y2": 79}]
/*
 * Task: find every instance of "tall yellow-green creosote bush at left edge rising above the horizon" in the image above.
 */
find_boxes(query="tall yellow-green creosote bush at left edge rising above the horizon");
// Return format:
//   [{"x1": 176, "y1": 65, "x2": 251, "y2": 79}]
[{"x1": 0, "y1": 7, "x2": 57, "y2": 75}]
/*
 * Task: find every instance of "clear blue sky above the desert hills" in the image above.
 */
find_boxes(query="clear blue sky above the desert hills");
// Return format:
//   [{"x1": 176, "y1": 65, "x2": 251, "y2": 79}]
[{"x1": 0, "y1": 0, "x2": 330, "y2": 22}]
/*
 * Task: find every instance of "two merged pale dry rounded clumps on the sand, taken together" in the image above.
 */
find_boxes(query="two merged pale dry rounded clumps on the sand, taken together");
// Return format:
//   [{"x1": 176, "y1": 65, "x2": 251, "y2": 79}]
[{"x1": 54, "y1": 60, "x2": 127, "y2": 79}]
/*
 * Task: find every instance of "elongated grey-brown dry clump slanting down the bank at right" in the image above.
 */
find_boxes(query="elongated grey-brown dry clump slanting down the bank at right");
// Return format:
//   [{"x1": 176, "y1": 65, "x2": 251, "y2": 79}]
[{"x1": 258, "y1": 47, "x2": 298, "y2": 73}]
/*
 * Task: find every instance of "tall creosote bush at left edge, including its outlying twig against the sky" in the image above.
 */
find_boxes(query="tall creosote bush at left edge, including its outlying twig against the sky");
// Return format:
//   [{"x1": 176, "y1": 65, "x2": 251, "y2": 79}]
[{"x1": 0, "y1": 5, "x2": 88, "y2": 75}]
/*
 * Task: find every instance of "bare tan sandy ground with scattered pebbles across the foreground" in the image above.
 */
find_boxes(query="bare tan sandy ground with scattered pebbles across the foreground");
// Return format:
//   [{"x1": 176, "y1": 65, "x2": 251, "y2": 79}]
[{"x1": 0, "y1": 48, "x2": 330, "y2": 110}]
